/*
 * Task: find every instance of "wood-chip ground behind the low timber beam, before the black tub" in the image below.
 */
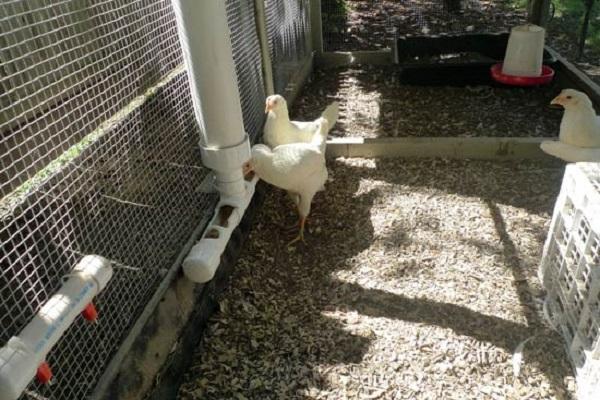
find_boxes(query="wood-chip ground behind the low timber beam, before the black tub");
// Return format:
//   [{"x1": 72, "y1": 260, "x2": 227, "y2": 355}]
[{"x1": 292, "y1": 66, "x2": 562, "y2": 138}]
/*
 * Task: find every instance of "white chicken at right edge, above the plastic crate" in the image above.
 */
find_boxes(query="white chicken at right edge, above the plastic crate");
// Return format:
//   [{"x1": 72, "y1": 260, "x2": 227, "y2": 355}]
[{"x1": 540, "y1": 89, "x2": 600, "y2": 162}]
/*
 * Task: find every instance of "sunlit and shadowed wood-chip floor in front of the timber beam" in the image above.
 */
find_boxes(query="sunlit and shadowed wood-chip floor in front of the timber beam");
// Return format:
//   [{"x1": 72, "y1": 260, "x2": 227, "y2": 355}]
[{"x1": 179, "y1": 159, "x2": 575, "y2": 400}]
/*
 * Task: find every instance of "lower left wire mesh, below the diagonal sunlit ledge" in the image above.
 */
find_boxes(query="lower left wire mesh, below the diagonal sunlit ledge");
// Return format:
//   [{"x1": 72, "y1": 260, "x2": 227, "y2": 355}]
[{"x1": 0, "y1": 73, "x2": 216, "y2": 399}]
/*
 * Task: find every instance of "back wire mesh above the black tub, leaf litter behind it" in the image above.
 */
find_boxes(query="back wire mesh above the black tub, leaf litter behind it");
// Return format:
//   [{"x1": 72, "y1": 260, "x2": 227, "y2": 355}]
[{"x1": 321, "y1": 0, "x2": 525, "y2": 51}]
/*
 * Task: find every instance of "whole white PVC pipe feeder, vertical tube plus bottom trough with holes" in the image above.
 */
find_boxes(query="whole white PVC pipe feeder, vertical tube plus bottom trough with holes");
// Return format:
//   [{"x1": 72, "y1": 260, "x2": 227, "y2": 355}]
[{"x1": 172, "y1": 0, "x2": 256, "y2": 283}]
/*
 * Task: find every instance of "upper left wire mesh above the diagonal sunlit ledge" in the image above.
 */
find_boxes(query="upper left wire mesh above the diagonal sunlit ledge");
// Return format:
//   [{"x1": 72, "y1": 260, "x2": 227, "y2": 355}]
[{"x1": 0, "y1": 0, "x2": 181, "y2": 199}]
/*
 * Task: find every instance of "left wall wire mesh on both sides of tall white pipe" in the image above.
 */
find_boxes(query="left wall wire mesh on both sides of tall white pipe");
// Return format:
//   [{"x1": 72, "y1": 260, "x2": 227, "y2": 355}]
[{"x1": 0, "y1": 0, "x2": 264, "y2": 400}]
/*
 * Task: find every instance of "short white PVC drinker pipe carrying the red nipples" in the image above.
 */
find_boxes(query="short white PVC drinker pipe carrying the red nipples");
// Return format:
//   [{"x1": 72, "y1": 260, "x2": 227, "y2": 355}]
[{"x1": 0, "y1": 256, "x2": 112, "y2": 400}]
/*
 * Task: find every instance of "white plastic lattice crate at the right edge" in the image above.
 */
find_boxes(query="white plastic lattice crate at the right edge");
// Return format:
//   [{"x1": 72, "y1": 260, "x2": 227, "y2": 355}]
[{"x1": 539, "y1": 163, "x2": 600, "y2": 400}]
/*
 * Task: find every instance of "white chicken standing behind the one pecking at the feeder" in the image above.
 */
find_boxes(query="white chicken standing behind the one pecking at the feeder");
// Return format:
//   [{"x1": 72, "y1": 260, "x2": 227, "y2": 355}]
[{"x1": 263, "y1": 94, "x2": 339, "y2": 149}]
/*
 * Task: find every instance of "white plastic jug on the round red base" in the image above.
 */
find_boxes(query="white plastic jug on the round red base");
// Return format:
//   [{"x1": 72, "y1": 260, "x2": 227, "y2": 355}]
[{"x1": 502, "y1": 24, "x2": 546, "y2": 77}]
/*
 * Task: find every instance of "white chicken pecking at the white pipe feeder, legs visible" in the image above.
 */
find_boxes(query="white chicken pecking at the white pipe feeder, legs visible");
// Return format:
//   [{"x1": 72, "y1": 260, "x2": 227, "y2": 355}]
[{"x1": 243, "y1": 114, "x2": 329, "y2": 244}]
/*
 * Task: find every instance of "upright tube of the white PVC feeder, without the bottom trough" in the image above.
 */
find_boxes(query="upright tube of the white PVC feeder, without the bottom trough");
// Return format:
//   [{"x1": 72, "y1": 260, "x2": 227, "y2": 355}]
[{"x1": 172, "y1": 0, "x2": 250, "y2": 198}]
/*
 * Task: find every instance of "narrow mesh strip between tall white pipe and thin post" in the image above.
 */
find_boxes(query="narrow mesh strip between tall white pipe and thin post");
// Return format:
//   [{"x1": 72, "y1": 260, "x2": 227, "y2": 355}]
[{"x1": 227, "y1": 0, "x2": 265, "y2": 140}]
